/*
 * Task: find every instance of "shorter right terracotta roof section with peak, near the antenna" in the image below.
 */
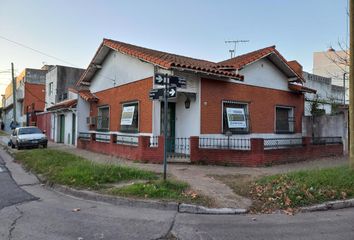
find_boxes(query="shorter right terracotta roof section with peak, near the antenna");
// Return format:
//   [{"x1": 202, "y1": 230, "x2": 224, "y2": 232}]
[{"x1": 217, "y1": 45, "x2": 305, "y2": 81}]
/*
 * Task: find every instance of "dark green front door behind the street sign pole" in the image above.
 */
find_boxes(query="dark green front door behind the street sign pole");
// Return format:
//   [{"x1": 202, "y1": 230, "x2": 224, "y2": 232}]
[{"x1": 161, "y1": 102, "x2": 176, "y2": 152}]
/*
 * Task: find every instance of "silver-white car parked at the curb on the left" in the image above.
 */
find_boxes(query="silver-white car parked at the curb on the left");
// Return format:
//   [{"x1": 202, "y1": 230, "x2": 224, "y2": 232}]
[{"x1": 9, "y1": 127, "x2": 48, "y2": 149}]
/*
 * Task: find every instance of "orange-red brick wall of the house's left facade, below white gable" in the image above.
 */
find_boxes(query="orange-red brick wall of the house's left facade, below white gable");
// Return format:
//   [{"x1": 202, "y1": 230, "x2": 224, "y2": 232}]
[{"x1": 90, "y1": 77, "x2": 153, "y2": 133}]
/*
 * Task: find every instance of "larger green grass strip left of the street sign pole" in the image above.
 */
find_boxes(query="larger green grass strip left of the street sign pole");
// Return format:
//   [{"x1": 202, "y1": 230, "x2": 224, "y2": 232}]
[{"x1": 16, "y1": 149, "x2": 158, "y2": 189}]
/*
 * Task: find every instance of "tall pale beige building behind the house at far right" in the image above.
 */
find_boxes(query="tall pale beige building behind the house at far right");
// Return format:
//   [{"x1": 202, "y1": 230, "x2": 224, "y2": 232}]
[{"x1": 313, "y1": 48, "x2": 349, "y2": 104}]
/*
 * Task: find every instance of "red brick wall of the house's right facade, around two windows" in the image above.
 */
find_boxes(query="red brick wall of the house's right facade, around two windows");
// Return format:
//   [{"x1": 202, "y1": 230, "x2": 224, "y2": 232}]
[{"x1": 201, "y1": 79, "x2": 304, "y2": 134}]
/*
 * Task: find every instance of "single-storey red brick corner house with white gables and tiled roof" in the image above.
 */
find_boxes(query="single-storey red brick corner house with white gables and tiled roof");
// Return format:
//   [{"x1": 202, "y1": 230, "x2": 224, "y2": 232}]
[{"x1": 77, "y1": 39, "x2": 342, "y2": 165}]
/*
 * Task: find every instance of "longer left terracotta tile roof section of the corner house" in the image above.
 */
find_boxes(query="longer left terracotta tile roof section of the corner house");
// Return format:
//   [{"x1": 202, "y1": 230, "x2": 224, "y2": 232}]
[{"x1": 78, "y1": 39, "x2": 243, "y2": 84}]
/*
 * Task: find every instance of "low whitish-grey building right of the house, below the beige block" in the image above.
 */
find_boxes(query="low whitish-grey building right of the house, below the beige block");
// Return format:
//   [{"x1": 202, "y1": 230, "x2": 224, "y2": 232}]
[{"x1": 303, "y1": 72, "x2": 344, "y2": 116}]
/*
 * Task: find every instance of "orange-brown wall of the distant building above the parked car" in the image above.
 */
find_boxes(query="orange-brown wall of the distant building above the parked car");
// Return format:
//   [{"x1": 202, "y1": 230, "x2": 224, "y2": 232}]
[{"x1": 23, "y1": 82, "x2": 45, "y2": 114}]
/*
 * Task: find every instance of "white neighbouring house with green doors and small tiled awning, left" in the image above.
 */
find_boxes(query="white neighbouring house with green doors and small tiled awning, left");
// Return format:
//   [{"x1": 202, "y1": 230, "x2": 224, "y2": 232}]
[{"x1": 37, "y1": 65, "x2": 84, "y2": 145}]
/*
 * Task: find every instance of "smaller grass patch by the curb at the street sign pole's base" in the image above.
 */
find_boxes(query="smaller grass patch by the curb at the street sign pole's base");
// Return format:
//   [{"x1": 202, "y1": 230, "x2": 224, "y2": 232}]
[{"x1": 105, "y1": 180, "x2": 212, "y2": 206}]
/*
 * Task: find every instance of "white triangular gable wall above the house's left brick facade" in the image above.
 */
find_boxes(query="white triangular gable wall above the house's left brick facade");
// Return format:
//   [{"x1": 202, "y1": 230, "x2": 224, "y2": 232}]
[{"x1": 90, "y1": 51, "x2": 154, "y2": 93}]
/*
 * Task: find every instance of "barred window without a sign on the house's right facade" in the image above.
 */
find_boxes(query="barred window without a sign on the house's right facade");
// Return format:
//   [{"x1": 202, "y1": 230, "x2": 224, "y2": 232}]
[{"x1": 275, "y1": 106, "x2": 295, "y2": 133}]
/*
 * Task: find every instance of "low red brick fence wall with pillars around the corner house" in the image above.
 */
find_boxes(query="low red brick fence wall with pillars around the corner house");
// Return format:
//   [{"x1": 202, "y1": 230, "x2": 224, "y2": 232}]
[{"x1": 77, "y1": 133, "x2": 343, "y2": 167}]
